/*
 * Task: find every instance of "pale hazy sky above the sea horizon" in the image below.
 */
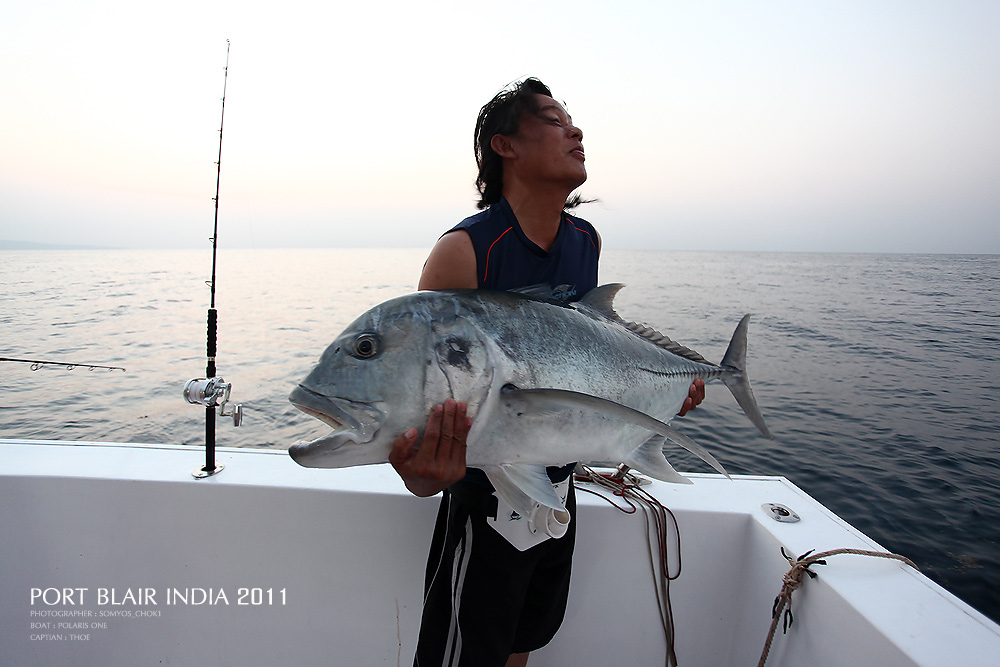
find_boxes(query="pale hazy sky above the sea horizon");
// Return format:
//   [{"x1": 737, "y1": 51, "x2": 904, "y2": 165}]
[{"x1": 0, "y1": 0, "x2": 1000, "y2": 253}]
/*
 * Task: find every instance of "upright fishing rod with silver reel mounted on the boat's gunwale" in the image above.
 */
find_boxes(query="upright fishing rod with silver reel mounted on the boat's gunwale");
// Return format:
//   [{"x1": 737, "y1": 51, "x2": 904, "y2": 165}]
[{"x1": 184, "y1": 39, "x2": 243, "y2": 479}]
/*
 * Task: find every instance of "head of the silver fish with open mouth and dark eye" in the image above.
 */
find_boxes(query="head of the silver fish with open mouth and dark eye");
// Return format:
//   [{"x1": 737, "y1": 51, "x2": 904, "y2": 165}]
[{"x1": 289, "y1": 292, "x2": 500, "y2": 468}]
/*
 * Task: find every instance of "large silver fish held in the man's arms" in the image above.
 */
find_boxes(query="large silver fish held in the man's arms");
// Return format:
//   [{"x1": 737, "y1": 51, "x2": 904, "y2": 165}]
[{"x1": 289, "y1": 285, "x2": 771, "y2": 512}]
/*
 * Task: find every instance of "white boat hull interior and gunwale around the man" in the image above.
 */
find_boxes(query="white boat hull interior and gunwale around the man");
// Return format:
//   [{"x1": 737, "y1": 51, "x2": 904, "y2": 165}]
[{"x1": 0, "y1": 440, "x2": 1000, "y2": 667}]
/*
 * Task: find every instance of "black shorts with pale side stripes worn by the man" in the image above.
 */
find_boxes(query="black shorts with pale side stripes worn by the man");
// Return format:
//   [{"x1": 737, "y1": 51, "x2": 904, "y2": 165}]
[{"x1": 413, "y1": 482, "x2": 576, "y2": 667}]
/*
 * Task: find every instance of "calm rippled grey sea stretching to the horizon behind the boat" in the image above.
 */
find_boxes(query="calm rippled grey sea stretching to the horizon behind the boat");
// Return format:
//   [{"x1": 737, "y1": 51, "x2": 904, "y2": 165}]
[{"x1": 0, "y1": 250, "x2": 1000, "y2": 620}]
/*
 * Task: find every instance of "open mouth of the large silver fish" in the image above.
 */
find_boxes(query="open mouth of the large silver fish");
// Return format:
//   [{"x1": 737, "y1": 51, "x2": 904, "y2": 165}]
[{"x1": 288, "y1": 385, "x2": 385, "y2": 468}]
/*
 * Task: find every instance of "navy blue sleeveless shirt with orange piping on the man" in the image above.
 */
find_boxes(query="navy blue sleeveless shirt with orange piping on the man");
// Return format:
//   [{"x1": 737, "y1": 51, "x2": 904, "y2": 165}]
[{"x1": 446, "y1": 198, "x2": 600, "y2": 488}]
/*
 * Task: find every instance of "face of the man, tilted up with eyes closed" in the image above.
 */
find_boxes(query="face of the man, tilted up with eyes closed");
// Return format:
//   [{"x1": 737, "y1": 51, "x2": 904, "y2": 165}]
[{"x1": 508, "y1": 94, "x2": 587, "y2": 192}]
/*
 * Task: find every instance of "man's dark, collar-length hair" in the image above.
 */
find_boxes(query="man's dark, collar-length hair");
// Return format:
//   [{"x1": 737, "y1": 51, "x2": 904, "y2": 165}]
[{"x1": 474, "y1": 77, "x2": 552, "y2": 208}]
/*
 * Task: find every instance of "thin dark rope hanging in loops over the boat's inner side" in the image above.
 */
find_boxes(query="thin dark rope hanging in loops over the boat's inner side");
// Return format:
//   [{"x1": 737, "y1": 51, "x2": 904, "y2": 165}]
[{"x1": 576, "y1": 464, "x2": 681, "y2": 667}]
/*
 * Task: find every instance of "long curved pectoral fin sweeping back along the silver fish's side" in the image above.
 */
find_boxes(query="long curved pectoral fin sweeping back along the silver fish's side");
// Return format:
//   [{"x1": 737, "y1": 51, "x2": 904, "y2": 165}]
[{"x1": 503, "y1": 385, "x2": 729, "y2": 477}]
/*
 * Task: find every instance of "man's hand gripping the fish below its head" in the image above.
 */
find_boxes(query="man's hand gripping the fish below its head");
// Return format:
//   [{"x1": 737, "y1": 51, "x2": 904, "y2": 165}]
[{"x1": 389, "y1": 398, "x2": 472, "y2": 498}]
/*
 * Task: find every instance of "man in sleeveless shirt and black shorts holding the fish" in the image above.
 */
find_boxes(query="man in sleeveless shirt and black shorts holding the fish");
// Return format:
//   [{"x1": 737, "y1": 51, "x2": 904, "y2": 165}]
[{"x1": 389, "y1": 78, "x2": 704, "y2": 667}]
